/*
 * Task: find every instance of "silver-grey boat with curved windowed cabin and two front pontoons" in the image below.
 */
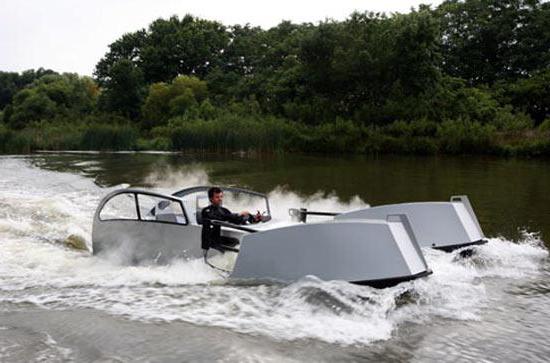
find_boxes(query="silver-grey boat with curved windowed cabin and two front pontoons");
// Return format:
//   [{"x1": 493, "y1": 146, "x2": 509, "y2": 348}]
[{"x1": 92, "y1": 186, "x2": 482, "y2": 287}]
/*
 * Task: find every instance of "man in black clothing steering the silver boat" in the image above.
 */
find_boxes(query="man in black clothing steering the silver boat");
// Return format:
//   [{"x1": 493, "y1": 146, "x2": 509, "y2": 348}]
[{"x1": 201, "y1": 187, "x2": 261, "y2": 251}]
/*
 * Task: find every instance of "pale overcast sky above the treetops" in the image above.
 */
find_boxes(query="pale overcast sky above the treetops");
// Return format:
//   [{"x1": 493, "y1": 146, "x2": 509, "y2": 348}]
[{"x1": 0, "y1": 0, "x2": 441, "y2": 75}]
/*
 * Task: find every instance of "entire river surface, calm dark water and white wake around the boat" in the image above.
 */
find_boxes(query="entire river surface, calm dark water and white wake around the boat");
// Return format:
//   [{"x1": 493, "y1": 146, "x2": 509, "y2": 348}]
[{"x1": 0, "y1": 153, "x2": 550, "y2": 362}]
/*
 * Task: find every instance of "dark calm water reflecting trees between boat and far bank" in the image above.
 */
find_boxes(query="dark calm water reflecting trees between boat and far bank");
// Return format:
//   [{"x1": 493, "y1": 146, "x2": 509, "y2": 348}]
[{"x1": 31, "y1": 153, "x2": 550, "y2": 245}]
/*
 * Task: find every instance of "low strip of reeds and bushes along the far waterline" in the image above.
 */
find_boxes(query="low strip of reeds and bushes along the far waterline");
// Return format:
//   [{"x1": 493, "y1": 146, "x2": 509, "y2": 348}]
[{"x1": 0, "y1": 114, "x2": 550, "y2": 157}]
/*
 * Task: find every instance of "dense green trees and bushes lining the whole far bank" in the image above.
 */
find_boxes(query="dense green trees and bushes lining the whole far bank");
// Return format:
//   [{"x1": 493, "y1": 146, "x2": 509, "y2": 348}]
[{"x1": 0, "y1": 0, "x2": 550, "y2": 157}]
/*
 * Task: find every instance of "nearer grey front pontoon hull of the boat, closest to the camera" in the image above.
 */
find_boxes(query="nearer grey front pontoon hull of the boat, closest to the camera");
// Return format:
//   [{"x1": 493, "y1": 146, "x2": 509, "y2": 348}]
[{"x1": 231, "y1": 216, "x2": 429, "y2": 284}]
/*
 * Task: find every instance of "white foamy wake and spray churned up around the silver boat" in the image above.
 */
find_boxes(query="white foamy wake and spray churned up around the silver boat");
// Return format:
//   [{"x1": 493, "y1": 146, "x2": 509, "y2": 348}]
[{"x1": 0, "y1": 158, "x2": 548, "y2": 345}]
